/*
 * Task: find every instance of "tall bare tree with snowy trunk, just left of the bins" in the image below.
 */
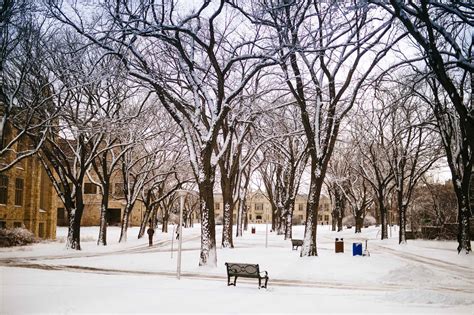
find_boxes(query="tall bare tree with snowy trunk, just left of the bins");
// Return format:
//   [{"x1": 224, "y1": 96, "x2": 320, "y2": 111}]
[{"x1": 237, "y1": 1, "x2": 403, "y2": 256}]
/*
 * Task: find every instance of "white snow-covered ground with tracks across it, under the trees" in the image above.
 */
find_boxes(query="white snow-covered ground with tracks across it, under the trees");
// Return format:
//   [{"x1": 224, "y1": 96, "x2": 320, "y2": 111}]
[{"x1": 0, "y1": 225, "x2": 474, "y2": 314}]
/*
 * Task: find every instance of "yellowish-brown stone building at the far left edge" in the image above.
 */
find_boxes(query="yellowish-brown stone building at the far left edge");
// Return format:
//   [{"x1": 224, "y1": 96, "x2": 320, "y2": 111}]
[{"x1": 0, "y1": 134, "x2": 56, "y2": 239}]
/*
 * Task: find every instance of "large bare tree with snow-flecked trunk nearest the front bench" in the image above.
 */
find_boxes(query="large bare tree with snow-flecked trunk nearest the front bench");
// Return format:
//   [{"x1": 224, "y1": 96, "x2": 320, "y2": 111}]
[{"x1": 48, "y1": 0, "x2": 274, "y2": 265}]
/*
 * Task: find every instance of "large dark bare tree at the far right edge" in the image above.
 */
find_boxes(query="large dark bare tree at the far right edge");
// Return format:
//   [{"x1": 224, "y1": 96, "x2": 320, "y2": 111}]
[{"x1": 369, "y1": 0, "x2": 474, "y2": 253}]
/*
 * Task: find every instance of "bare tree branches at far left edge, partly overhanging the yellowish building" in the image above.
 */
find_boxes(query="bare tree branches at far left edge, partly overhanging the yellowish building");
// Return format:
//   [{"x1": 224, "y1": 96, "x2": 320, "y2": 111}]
[{"x1": 0, "y1": 0, "x2": 57, "y2": 171}]
